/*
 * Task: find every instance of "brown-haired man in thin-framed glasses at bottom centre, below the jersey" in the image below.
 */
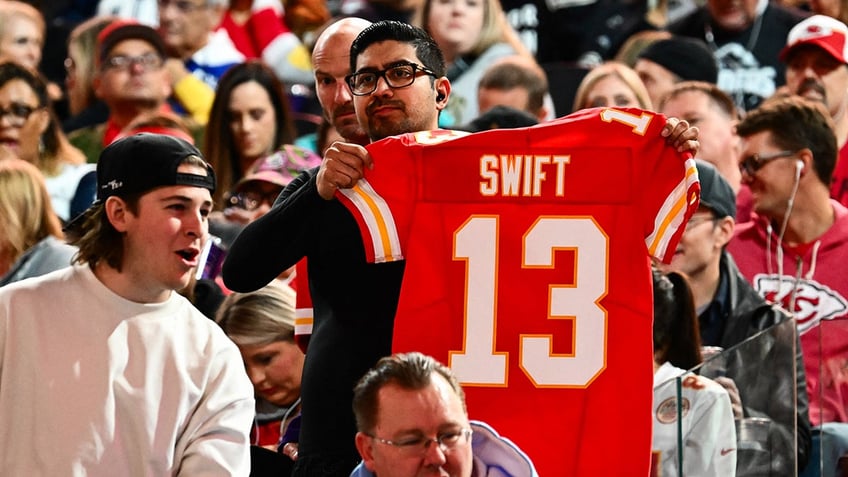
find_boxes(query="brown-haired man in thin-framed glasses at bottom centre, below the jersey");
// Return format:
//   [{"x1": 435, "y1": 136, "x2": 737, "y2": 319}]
[{"x1": 352, "y1": 352, "x2": 538, "y2": 477}]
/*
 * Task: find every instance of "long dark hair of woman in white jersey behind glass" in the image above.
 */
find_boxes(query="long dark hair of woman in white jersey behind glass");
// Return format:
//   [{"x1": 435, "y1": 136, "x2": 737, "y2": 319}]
[{"x1": 653, "y1": 269, "x2": 702, "y2": 369}]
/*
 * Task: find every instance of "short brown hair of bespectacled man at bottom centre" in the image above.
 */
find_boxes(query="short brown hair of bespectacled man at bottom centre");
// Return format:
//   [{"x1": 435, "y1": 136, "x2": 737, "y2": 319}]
[{"x1": 353, "y1": 352, "x2": 466, "y2": 435}]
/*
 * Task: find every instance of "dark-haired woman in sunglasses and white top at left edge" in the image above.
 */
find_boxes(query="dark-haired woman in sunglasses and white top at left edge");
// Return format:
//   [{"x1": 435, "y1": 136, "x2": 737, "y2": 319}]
[{"x1": 0, "y1": 61, "x2": 94, "y2": 220}]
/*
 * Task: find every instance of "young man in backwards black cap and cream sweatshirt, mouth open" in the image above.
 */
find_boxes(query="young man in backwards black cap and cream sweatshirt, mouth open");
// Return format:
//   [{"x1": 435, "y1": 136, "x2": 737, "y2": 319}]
[{"x1": 0, "y1": 134, "x2": 254, "y2": 476}]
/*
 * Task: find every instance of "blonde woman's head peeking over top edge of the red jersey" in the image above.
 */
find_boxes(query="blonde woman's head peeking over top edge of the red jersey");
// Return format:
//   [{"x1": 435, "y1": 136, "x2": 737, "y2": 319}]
[{"x1": 573, "y1": 61, "x2": 653, "y2": 111}]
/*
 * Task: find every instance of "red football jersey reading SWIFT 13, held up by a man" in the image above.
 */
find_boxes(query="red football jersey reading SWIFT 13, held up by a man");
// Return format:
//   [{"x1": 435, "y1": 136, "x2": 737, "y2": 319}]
[{"x1": 337, "y1": 109, "x2": 699, "y2": 477}]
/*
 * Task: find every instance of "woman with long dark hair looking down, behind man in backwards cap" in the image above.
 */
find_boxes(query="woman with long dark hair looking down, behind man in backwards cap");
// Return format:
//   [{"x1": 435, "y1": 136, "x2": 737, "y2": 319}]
[{"x1": 204, "y1": 60, "x2": 296, "y2": 206}]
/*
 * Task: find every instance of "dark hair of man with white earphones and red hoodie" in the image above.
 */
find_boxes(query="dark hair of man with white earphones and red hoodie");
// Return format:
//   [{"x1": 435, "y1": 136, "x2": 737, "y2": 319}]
[{"x1": 736, "y1": 96, "x2": 839, "y2": 185}]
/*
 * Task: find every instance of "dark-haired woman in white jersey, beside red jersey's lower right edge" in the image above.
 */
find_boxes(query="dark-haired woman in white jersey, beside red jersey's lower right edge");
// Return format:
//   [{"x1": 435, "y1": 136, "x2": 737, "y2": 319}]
[{"x1": 651, "y1": 270, "x2": 736, "y2": 477}]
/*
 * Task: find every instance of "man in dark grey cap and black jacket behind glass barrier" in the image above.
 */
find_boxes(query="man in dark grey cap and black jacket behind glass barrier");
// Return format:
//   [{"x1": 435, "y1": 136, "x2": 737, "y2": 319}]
[{"x1": 665, "y1": 160, "x2": 810, "y2": 475}]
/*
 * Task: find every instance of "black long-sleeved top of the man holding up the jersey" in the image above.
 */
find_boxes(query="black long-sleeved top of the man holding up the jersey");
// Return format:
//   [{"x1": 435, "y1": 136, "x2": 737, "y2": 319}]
[{"x1": 223, "y1": 168, "x2": 404, "y2": 477}]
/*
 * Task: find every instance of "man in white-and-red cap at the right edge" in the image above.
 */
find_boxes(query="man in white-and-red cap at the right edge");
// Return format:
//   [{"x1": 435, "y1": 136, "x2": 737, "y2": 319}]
[{"x1": 780, "y1": 15, "x2": 848, "y2": 206}]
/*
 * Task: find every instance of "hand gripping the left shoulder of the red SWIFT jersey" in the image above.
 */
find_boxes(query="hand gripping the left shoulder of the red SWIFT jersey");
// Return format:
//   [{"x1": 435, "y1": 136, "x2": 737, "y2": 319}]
[{"x1": 316, "y1": 141, "x2": 374, "y2": 200}]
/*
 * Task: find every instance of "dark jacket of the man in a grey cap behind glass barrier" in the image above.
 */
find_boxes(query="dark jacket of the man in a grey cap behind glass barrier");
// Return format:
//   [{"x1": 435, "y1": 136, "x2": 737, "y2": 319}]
[{"x1": 704, "y1": 251, "x2": 811, "y2": 476}]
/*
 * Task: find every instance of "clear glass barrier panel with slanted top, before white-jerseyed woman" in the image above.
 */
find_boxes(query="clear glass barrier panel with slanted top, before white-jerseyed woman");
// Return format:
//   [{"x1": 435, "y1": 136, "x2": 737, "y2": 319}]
[{"x1": 654, "y1": 320, "x2": 803, "y2": 477}]
